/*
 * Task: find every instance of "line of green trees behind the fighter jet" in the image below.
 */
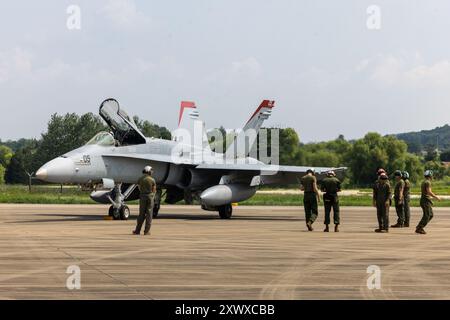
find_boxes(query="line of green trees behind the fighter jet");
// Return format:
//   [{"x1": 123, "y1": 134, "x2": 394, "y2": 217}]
[{"x1": 0, "y1": 113, "x2": 450, "y2": 186}]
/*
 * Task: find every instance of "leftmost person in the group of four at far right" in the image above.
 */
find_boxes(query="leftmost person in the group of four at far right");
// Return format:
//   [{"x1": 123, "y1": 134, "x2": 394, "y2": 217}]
[{"x1": 373, "y1": 172, "x2": 391, "y2": 233}]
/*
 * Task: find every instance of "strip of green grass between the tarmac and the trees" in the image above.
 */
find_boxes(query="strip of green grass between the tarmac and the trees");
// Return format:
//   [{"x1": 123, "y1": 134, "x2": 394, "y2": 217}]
[{"x1": 0, "y1": 185, "x2": 450, "y2": 207}]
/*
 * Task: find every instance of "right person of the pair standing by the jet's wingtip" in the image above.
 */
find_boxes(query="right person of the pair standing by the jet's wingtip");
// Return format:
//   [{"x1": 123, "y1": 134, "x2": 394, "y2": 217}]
[{"x1": 321, "y1": 171, "x2": 341, "y2": 232}]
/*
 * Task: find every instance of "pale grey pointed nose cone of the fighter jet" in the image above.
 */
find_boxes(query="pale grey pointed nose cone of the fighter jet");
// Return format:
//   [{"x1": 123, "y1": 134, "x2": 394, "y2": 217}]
[{"x1": 36, "y1": 157, "x2": 75, "y2": 183}]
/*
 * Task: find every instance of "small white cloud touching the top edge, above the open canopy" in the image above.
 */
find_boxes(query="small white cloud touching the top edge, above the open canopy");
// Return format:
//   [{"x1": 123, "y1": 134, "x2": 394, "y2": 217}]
[{"x1": 101, "y1": 0, "x2": 150, "y2": 29}]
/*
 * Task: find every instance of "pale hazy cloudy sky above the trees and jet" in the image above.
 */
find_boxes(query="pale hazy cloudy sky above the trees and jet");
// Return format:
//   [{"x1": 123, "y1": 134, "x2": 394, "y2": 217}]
[{"x1": 0, "y1": 0, "x2": 450, "y2": 142}]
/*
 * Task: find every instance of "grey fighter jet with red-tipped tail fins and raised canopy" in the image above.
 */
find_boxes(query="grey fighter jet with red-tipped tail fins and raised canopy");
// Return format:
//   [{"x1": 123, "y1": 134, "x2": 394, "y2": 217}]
[{"x1": 36, "y1": 98, "x2": 346, "y2": 220}]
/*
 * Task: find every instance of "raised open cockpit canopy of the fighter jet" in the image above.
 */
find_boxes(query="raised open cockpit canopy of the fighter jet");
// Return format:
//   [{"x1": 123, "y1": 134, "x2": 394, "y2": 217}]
[{"x1": 99, "y1": 99, "x2": 146, "y2": 145}]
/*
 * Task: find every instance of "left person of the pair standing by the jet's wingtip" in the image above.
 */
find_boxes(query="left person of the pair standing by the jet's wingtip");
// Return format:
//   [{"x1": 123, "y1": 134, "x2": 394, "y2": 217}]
[{"x1": 300, "y1": 169, "x2": 320, "y2": 231}]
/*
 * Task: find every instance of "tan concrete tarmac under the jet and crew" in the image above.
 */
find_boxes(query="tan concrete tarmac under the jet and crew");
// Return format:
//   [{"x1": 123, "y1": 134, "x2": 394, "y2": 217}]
[{"x1": 0, "y1": 204, "x2": 450, "y2": 299}]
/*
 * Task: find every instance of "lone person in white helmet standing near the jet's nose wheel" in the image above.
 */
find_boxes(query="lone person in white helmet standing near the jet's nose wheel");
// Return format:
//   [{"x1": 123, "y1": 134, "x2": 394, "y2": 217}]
[{"x1": 133, "y1": 166, "x2": 156, "y2": 235}]
